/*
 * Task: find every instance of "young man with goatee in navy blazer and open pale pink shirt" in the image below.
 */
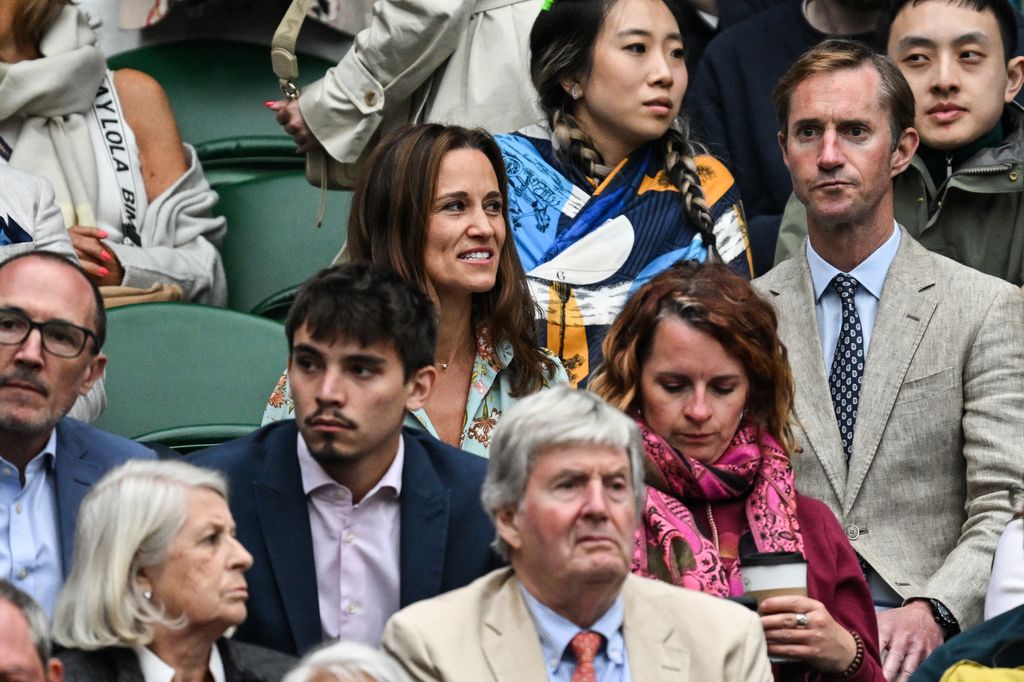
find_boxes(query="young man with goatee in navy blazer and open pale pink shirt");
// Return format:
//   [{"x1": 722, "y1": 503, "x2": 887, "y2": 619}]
[{"x1": 193, "y1": 263, "x2": 498, "y2": 653}]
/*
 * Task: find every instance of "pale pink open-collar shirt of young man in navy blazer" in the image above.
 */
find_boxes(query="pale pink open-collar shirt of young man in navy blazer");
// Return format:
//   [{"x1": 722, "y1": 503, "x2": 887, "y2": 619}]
[{"x1": 298, "y1": 434, "x2": 406, "y2": 646}]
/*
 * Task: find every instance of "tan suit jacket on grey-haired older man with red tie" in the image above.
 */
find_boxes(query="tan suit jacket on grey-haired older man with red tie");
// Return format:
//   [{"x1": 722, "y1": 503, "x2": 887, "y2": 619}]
[{"x1": 384, "y1": 568, "x2": 771, "y2": 682}]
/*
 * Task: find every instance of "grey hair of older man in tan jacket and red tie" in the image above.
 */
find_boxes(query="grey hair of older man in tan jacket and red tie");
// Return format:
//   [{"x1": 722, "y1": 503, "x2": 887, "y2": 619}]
[{"x1": 480, "y1": 384, "x2": 644, "y2": 558}]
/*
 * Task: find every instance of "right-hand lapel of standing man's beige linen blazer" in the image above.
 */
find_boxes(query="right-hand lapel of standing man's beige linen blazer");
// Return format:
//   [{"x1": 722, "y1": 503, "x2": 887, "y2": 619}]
[{"x1": 842, "y1": 233, "x2": 937, "y2": 514}]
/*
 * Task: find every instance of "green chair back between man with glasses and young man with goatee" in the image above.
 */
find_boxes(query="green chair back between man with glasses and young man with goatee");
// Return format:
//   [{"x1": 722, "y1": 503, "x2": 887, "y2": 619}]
[{"x1": 95, "y1": 303, "x2": 288, "y2": 442}]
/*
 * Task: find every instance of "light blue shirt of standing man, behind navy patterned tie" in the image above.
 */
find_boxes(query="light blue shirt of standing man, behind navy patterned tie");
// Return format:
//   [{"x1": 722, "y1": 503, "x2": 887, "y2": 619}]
[{"x1": 807, "y1": 222, "x2": 900, "y2": 377}]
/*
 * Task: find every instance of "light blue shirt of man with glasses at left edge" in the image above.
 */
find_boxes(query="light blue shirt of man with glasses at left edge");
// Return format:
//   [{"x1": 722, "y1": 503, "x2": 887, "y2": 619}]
[{"x1": 0, "y1": 429, "x2": 63, "y2": 615}]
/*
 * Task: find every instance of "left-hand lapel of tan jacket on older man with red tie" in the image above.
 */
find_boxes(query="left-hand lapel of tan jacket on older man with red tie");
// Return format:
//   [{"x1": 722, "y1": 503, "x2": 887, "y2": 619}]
[{"x1": 480, "y1": 569, "x2": 552, "y2": 682}]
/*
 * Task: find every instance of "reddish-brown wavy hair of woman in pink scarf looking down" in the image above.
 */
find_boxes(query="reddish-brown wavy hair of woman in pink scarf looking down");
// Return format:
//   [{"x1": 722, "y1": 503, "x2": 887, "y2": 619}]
[{"x1": 590, "y1": 261, "x2": 796, "y2": 453}]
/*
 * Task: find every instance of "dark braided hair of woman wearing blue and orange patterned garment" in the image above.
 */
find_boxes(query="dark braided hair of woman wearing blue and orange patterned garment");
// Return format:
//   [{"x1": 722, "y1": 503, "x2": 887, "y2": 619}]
[{"x1": 529, "y1": 0, "x2": 722, "y2": 262}]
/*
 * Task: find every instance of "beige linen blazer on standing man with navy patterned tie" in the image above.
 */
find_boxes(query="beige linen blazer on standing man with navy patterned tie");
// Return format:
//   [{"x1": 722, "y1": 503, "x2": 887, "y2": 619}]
[{"x1": 755, "y1": 226, "x2": 1024, "y2": 628}]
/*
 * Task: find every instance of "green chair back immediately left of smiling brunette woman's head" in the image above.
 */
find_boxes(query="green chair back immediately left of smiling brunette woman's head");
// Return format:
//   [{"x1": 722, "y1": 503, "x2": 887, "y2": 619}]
[{"x1": 216, "y1": 172, "x2": 351, "y2": 318}]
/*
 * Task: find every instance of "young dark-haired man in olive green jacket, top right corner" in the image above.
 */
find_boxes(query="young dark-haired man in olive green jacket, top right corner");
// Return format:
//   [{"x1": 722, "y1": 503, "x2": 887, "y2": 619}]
[{"x1": 775, "y1": 0, "x2": 1024, "y2": 286}]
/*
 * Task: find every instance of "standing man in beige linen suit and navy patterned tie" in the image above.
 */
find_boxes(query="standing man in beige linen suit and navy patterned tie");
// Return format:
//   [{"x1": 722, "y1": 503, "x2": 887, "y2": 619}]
[{"x1": 756, "y1": 41, "x2": 1024, "y2": 680}]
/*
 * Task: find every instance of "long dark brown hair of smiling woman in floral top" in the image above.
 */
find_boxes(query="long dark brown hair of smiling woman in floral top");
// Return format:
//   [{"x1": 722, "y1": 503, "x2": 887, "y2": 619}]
[{"x1": 348, "y1": 123, "x2": 555, "y2": 396}]
